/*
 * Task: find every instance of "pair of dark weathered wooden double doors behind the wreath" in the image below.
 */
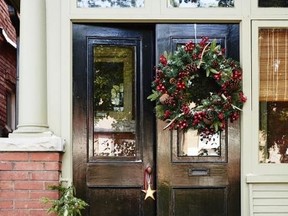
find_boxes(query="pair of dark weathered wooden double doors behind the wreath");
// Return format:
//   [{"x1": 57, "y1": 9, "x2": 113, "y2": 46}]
[{"x1": 73, "y1": 24, "x2": 240, "y2": 216}]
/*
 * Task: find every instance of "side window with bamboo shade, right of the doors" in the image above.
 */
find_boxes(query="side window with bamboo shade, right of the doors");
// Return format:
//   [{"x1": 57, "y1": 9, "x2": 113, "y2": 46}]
[{"x1": 258, "y1": 28, "x2": 288, "y2": 163}]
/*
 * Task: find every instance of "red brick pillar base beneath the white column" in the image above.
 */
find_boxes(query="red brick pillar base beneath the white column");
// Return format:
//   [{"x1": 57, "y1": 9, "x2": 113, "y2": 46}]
[{"x1": 0, "y1": 152, "x2": 61, "y2": 216}]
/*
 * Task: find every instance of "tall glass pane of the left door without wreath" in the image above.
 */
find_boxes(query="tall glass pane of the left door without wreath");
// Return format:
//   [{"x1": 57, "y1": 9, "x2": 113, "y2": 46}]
[{"x1": 93, "y1": 45, "x2": 136, "y2": 157}]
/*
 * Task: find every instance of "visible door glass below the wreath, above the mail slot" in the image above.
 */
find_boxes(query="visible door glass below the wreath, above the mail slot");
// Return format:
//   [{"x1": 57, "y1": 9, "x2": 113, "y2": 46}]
[{"x1": 178, "y1": 130, "x2": 221, "y2": 157}]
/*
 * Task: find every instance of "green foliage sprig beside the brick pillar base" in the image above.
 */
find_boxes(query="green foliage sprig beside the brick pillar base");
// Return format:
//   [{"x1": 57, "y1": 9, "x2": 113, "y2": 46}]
[{"x1": 42, "y1": 185, "x2": 88, "y2": 216}]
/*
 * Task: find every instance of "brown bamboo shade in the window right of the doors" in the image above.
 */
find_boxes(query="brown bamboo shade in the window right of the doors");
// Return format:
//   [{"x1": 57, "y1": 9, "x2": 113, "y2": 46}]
[{"x1": 259, "y1": 28, "x2": 288, "y2": 102}]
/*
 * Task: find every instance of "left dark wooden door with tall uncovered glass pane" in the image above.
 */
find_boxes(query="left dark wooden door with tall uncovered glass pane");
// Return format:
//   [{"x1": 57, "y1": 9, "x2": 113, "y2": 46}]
[{"x1": 73, "y1": 24, "x2": 156, "y2": 216}]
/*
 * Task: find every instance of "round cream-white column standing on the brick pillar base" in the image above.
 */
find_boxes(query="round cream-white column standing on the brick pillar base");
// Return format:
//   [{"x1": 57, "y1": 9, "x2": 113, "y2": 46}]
[{"x1": 13, "y1": 0, "x2": 49, "y2": 134}]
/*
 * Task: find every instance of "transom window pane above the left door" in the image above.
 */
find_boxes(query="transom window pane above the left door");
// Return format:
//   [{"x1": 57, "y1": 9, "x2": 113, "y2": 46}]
[{"x1": 77, "y1": 0, "x2": 144, "y2": 8}]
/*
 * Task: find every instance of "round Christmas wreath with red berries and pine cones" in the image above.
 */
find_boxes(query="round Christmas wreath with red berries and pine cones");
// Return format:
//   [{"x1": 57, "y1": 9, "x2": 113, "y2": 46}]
[{"x1": 148, "y1": 37, "x2": 246, "y2": 135}]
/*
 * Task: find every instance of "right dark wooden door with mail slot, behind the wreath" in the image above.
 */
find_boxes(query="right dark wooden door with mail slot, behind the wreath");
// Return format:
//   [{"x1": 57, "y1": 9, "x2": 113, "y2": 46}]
[{"x1": 156, "y1": 24, "x2": 240, "y2": 216}]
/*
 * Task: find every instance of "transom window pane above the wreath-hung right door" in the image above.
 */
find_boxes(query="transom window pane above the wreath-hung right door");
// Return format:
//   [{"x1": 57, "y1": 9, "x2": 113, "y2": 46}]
[{"x1": 167, "y1": 0, "x2": 234, "y2": 8}]
